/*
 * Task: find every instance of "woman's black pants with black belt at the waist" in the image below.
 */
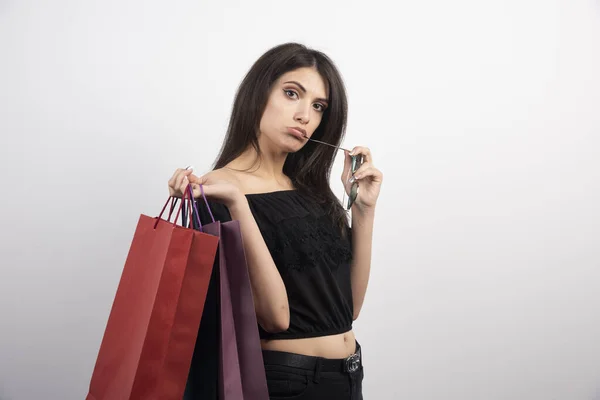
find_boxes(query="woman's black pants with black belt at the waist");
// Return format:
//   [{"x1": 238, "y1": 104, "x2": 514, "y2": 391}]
[{"x1": 263, "y1": 342, "x2": 364, "y2": 400}]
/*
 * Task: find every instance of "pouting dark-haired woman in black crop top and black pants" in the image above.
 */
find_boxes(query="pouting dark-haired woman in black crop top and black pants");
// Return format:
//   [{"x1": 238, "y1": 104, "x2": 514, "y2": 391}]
[{"x1": 169, "y1": 43, "x2": 383, "y2": 400}]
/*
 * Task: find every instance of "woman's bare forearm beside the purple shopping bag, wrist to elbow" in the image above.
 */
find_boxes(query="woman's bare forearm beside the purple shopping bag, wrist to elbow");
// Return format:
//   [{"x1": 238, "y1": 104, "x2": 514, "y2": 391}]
[{"x1": 229, "y1": 197, "x2": 290, "y2": 332}]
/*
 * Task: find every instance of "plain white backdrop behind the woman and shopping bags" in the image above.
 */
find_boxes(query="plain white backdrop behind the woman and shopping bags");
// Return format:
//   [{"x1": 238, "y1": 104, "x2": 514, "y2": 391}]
[{"x1": 0, "y1": 0, "x2": 600, "y2": 400}]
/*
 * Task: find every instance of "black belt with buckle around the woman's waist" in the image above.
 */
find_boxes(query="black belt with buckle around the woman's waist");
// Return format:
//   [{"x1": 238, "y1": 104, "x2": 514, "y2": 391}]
[{"x1": 262, "y1": 342, "x2": 362, "y2": 373}]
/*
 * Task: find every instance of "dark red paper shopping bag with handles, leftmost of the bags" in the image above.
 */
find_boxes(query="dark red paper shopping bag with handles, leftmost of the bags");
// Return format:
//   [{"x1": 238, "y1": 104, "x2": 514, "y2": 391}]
[{"x1": 87, "y1": 188, "x2": 219, "y2": 400}]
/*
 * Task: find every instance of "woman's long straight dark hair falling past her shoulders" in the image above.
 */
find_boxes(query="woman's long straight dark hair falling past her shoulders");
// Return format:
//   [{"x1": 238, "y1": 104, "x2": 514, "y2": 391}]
[{"x1": 214, "y1": 43, "x2": 348, "y2": 231}]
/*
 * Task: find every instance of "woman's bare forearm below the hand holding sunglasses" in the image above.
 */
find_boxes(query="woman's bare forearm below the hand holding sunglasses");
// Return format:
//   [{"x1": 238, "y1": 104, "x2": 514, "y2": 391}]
[{"x1": 351, "y1": 206, "x2": 375, "y2": 319}]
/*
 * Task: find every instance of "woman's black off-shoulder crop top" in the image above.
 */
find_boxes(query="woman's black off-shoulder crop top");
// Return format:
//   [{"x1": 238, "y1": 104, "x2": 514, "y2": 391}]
[{"x1": 196, "y1": 190, "x2": 353, "y2": 339}]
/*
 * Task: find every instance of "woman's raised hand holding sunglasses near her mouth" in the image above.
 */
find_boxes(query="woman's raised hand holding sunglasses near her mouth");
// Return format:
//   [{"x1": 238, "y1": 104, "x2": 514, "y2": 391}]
[{"x1": 342, "y1": 146, "x2": 383, "y2": 211}]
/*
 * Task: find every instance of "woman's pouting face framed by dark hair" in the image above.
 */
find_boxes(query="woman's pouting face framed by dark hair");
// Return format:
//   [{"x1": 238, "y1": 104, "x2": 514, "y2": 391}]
[{"x1": 258, "y1": 68, "x2": 328, "y2": 153}]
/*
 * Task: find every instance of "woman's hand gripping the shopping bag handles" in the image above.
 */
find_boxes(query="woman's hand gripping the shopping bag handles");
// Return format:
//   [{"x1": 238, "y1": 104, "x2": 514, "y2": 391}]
[{"x1": 169, "y1": 168, "x2": 244, "y2": 207}]
